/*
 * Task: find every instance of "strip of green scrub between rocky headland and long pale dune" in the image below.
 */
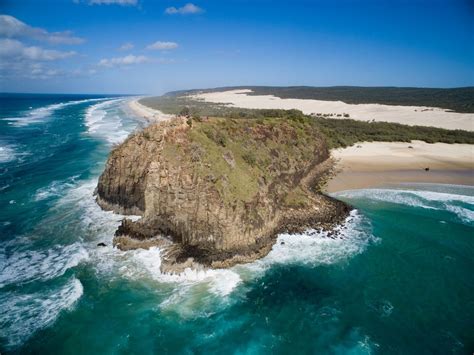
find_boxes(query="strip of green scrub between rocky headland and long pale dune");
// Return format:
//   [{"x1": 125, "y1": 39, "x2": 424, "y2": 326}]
[{"x1": 140, "y1": 95, "x2": 474, "y2": 148}]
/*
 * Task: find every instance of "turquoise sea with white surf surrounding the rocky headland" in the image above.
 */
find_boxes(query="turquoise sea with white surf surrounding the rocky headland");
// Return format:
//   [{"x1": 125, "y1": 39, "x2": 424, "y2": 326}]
[{"x1": 0, "y1": 95, "x2": 474, "y2": 354}]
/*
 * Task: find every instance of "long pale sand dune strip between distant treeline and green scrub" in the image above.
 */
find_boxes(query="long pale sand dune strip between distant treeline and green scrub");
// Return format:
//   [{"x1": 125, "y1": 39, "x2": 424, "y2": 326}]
[{"x1": 191, "y1": 89, "x2": 474, "y2": 131}]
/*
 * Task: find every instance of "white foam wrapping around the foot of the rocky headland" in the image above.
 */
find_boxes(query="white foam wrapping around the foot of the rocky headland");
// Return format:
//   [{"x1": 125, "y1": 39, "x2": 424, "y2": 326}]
[{"x1": 19, "y1": 175, "x2": 373, "y2": 317}]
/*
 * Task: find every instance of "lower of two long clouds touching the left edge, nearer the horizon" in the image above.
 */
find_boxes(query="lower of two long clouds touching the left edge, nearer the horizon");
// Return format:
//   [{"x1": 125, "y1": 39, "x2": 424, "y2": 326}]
[{"x1": 0, "y1": 39, "x2": 76, "y2": 62}]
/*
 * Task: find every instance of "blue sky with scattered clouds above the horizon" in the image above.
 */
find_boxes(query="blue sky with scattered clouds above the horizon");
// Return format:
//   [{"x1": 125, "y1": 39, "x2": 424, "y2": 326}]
[{"x1": 0, "y1": 0, "x2": 474, "y2": 94}]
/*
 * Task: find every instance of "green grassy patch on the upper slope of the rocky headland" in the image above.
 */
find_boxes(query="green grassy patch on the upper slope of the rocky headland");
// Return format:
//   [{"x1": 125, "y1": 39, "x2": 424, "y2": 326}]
[{"x1": 184, "y1": 117, "x2": 324, "y2": 204}]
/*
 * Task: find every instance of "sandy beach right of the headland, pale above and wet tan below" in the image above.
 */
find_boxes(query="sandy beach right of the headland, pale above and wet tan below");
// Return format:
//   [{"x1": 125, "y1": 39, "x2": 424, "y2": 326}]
[{"x1": 325, "y1": 141, "x2": 474, "y2": 193}]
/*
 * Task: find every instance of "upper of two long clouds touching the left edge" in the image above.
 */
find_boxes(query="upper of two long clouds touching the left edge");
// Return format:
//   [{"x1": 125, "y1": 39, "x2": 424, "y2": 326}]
[{"x1": 0, "y1": 15, "x2": 84, "y2": 44}]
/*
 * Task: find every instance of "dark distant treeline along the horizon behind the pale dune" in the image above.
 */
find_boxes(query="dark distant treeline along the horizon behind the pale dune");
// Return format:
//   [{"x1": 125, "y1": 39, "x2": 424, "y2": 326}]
[{"x1": 167, "y1": 86, "x2": 474, "y2": 113}]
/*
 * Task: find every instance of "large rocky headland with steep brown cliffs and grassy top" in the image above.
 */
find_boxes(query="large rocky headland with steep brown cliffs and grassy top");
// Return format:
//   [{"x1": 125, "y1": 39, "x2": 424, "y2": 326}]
[{"x1": 97, "y1": 118, "x2": 348, "y2": 270}]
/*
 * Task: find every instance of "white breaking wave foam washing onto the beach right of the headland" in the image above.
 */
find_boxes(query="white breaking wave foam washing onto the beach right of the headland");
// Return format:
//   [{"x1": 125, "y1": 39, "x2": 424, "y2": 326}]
[{"x1": 335, "y1": 189, "x2": 474, "y2": 223}]
